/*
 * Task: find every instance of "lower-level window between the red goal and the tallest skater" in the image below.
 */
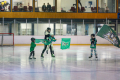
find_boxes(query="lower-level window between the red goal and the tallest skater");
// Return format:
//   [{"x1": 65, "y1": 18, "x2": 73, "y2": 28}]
[{"x1": 12, "y1": 19, "x2": 34, "y2": 35}]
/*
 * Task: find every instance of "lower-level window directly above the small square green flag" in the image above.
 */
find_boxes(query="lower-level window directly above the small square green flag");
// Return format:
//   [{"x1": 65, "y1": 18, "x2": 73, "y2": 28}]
[{"x1": 55, "y1": 19, "x2": 77, "y2": 35}]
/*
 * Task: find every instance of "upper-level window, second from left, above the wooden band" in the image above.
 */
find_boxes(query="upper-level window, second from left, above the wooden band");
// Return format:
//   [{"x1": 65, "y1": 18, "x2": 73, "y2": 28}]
[{"x1": 12, "y1": 0, "x2": 33, "y2": 12}]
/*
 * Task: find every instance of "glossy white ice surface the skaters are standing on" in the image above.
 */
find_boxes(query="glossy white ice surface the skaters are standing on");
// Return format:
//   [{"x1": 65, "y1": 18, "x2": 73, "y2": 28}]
[{"x1": 0, "y1": 46, "x2": 120, "y2": 80}]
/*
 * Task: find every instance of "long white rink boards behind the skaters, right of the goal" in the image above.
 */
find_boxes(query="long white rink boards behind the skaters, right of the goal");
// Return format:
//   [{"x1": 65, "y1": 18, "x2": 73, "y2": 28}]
[{"x1": 14, "y1": 36, "x2": 116, "y2": 44}]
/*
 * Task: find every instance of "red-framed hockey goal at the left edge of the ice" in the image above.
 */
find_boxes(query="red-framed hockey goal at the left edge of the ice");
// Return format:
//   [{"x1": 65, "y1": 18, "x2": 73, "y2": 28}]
[{"x1": 0, "y1": 33, "x2": 14, "y2": 46}]
